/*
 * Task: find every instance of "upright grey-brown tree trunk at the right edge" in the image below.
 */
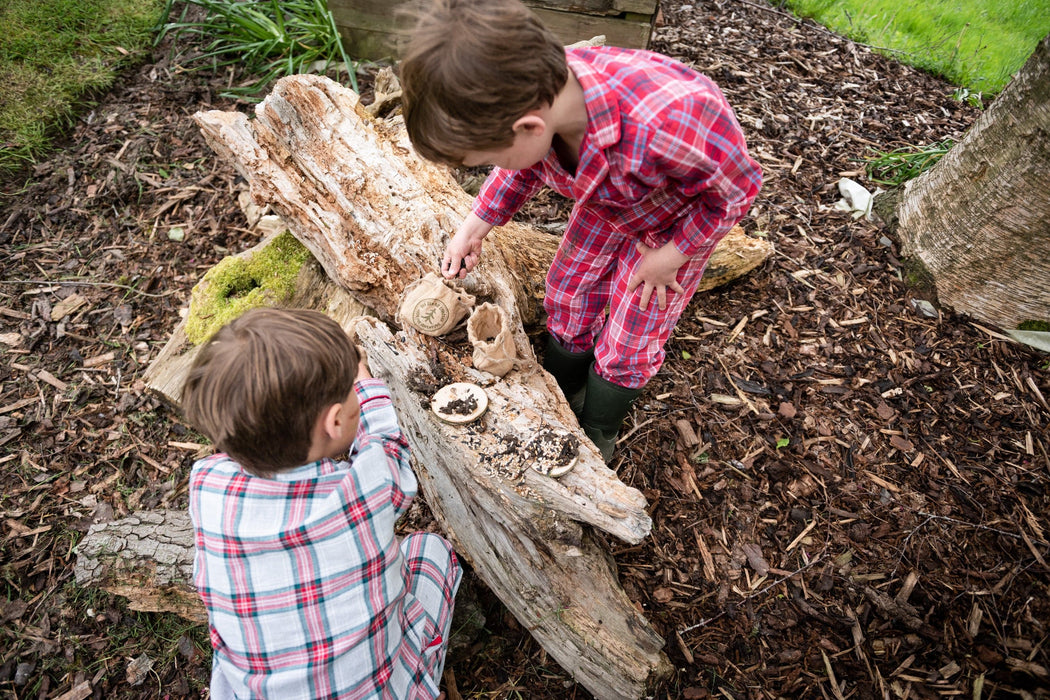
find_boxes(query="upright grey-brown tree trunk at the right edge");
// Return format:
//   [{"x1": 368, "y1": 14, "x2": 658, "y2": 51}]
[{"x1": 876, "y1": 36, "x2": 1050, "y2": 328}]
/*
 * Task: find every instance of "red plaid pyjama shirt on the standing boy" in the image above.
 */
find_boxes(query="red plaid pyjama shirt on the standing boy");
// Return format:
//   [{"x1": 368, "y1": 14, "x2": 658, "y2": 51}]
[{"x1": 474, "y1": 47, "x2": 761, "y2": 256}]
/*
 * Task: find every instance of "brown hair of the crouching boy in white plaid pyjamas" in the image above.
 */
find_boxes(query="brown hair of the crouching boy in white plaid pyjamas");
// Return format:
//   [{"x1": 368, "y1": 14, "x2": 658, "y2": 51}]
[{"x1": 182, "y1": 309, "x2": 358, "y2": 476}]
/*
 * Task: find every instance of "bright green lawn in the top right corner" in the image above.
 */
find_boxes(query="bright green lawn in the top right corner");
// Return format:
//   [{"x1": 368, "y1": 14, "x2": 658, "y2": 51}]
[{"x1": 781, "y1": 0, "x2": 1050, "y2": 94}]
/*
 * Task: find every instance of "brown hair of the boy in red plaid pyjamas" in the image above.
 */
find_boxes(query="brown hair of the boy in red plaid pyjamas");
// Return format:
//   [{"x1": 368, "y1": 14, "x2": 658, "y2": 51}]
[{"x1": 401, "y1": 0, "x2": 569, "y2": 165}]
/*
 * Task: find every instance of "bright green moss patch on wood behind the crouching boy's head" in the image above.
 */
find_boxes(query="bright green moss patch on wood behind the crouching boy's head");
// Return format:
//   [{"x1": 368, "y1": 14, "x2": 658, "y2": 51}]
[{"x1": 186, "y1": 232, "x2": 311, "y2": 345}]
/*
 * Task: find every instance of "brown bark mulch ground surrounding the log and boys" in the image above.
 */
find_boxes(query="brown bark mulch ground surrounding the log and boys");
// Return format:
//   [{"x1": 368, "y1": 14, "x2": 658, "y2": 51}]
[{"x1": 0, "y1": 0, "x2": 1050, "y2": 700}]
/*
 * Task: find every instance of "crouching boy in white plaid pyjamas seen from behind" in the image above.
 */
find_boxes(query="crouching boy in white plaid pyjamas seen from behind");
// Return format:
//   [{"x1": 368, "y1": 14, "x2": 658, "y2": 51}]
[{"x1": 183, "y1": 309, "x2": 462, "y2": 700}]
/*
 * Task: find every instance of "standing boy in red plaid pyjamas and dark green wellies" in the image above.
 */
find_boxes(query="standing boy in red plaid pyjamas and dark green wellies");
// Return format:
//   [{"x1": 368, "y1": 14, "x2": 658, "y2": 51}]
[{"x1": 401, "y1": 0, "x2": 761, "y2": 461}]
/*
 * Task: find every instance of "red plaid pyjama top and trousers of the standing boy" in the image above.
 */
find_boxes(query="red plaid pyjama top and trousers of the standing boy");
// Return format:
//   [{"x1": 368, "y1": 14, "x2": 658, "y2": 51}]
[{"x1": 474, "y1": 47, "x2": 761, "y2": 388}]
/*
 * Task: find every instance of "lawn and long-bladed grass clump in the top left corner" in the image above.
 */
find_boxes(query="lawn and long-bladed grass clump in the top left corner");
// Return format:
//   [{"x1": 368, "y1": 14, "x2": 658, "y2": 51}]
[{"x1": 0, "y1": 0, "x2": 357, "y2": 176}]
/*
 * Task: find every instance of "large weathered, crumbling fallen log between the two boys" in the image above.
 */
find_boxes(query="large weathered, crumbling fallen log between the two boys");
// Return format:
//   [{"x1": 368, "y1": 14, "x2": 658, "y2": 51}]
[{"x1": 78, "y1": 76, "x2": 769, "y2": 698}]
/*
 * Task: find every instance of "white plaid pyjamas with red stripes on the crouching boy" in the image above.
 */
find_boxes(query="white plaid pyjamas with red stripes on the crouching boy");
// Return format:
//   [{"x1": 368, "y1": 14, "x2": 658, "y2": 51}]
[{"x1": 189, "y1": 379, "x2": 461, "y2": 700}]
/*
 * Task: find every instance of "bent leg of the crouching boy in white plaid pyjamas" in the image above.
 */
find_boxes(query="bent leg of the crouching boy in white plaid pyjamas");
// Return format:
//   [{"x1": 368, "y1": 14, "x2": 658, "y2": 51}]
[{"x1": 401, "y1": 532, "x2": 463, "y2": 683}]
